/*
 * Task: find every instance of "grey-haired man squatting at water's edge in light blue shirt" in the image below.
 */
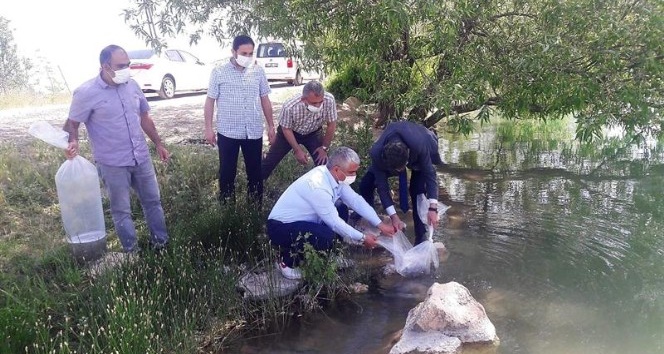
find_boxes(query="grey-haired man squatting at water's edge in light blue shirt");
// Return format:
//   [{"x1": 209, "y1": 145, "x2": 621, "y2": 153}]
[{"x1": 267, "y1": 147, "x2": 395, "y2": 279}]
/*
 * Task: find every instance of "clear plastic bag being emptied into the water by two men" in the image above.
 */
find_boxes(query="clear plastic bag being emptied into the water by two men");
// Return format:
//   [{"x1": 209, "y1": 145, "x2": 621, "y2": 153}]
[{"x1": 378, "y1": 194, "x2": 448, "y2": 277}]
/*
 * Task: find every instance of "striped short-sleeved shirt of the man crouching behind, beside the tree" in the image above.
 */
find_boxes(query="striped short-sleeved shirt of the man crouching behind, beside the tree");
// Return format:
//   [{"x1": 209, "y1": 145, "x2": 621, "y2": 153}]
[{"x1": 279, "y1": 92, "x2": 337, "y2": 135}]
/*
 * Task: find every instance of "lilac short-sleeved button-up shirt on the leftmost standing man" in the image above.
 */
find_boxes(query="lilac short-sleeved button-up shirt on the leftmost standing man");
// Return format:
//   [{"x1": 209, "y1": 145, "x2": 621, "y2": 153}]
[{"x1": 69, "y1": 75, "x2": 150, "y2": 167}]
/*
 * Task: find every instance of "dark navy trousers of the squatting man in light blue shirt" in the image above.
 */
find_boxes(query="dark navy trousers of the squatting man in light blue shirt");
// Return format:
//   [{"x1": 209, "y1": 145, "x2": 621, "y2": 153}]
[{"x1": 266, "y1": 203, "x2": 348, "y2": 268}]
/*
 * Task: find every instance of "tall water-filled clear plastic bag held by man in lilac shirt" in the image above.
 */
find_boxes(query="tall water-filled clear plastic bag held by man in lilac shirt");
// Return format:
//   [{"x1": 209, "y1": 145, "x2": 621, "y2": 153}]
[{"x1": 28, "y1": 122, "x2": 106, "y2": 243}]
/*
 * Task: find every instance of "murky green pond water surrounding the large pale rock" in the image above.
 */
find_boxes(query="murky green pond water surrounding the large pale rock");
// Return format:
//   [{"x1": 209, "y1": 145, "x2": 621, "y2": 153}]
[{"x1": 245, "y1": 121, "x2": 664, "y2": 354}]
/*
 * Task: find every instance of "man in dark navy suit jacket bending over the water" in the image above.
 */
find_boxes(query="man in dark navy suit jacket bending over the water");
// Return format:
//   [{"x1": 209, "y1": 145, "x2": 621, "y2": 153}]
[{"x1": 360, "y1": 121, "x2": 442, "y2": 244}]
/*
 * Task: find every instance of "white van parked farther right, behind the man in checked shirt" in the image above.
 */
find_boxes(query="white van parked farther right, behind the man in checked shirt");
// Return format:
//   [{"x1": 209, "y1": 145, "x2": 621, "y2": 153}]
[{"x1": 256, "y1": 42, "x2": 323, "y2": 85}]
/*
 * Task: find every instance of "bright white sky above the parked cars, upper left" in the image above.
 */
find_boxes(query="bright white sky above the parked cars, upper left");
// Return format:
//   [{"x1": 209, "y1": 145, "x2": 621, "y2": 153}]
[{"x1": 0, "y1": 0, "x2": 231, "y2": 91}]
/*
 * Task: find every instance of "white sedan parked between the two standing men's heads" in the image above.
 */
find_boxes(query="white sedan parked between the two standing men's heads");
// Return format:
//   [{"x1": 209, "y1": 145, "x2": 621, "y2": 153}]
[{"x1": 127, "y1": 49, "x2": 212, "y2": 98}]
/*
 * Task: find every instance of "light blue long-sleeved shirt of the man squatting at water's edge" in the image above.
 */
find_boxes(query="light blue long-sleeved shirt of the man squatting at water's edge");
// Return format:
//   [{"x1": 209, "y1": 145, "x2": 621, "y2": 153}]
[{"x1": 268, "y1": 166, "x2": 381, "y2": 241}]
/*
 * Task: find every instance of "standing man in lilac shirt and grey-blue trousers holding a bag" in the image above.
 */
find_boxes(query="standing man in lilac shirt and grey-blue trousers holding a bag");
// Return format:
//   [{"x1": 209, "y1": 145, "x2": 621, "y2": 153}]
[{"x1": 64, "y1": 45, "x2": 169, "y2": 252}]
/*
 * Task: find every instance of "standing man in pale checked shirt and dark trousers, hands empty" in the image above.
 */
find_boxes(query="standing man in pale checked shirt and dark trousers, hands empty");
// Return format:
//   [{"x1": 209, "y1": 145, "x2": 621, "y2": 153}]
[{"x1": 203, "y1": 36, "x2": 275, "y2": 204}]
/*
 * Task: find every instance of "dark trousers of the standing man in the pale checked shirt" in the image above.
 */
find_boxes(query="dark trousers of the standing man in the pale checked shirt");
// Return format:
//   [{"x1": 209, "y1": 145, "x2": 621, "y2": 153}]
[{"x1": 217, "y1": 133, "x2": 263, "y2": 204}]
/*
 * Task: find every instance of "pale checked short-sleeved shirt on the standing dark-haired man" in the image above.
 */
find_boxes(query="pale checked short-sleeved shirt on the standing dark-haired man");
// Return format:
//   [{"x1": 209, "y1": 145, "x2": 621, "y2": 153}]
[{"x1": 207, "y1": 61, "x2": 271, "y2": 139}]
